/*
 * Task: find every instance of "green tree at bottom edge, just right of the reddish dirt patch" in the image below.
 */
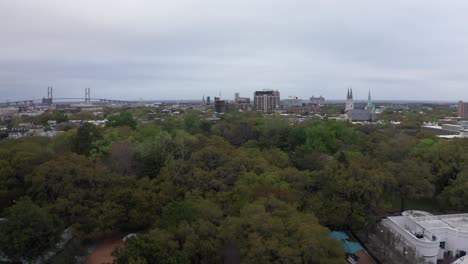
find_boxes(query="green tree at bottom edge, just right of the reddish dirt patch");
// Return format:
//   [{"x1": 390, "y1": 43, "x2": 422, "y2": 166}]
[{"x1": 114, "y1": 195, "x2": 222, "y2": 263}]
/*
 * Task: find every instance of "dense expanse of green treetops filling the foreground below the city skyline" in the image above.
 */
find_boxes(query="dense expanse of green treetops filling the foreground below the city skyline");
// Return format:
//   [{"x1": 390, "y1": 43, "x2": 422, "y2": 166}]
[{"x1": 0, "y1": 111, "x2": 468, "y2": 263}]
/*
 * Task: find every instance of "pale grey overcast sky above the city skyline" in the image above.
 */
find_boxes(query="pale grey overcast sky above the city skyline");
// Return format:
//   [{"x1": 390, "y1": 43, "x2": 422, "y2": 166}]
[{"x1": 0, "y1": 0, "x2": 468, "y2": 101}]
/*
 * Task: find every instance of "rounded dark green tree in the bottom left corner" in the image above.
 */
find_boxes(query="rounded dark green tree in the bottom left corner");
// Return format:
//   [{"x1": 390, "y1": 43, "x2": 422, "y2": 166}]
[{"x1": 0, "y1": 199, "x2": 61, "y2": 261}]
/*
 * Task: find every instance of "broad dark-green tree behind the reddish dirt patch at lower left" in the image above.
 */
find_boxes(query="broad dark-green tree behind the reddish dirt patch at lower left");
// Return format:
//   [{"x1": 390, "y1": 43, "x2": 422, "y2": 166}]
[{"x1": 29, "y1": 154, "x2": 158, "y2": 240}]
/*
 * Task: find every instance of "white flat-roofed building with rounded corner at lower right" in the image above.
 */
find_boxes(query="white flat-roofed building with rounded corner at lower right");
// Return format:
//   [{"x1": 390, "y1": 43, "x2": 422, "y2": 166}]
[{"x1": 382, "y1": 211, "x2": 468, "y2": 264}]
